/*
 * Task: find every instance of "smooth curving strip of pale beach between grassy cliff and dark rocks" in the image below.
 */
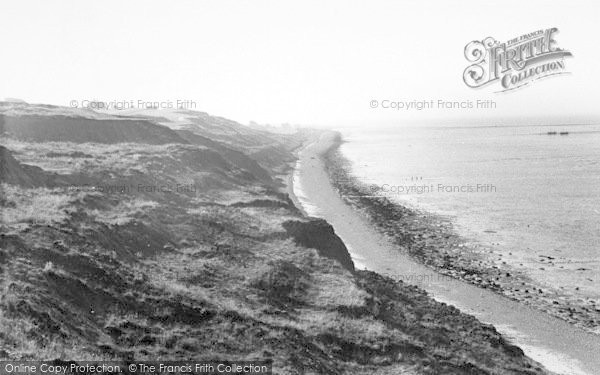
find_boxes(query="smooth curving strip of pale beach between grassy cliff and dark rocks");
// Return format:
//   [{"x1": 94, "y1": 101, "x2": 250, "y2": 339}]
[{"x1": 290, "y1": 132, "x2": 600, "y2": 374}]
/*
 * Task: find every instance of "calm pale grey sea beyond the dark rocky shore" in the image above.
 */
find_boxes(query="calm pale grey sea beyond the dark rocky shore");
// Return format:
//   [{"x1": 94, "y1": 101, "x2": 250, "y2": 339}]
[{"x1": 340, "y1": 126, "x2": 600, "y2": 302}]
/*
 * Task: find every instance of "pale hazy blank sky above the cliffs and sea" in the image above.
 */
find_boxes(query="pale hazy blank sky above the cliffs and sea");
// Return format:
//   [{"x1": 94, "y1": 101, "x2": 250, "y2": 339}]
[{"x1": 0, "y1": 0, "x2": 600, "y2": 126}]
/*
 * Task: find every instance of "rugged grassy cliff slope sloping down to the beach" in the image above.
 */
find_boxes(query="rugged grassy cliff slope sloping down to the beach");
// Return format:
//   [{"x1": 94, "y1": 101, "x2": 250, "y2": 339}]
[{"x1": 0, "y1": 104, "x2": 544, "y2": 374}]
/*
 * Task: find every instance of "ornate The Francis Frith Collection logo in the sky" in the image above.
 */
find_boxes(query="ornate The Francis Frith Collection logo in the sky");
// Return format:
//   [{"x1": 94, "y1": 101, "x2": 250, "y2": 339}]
[{"x1": 463, "y1": 27, "x2": 572, "y2": 92}]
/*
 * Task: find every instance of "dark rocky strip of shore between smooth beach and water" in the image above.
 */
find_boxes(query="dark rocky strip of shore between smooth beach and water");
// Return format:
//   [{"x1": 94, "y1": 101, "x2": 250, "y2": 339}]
[{"x1": 323, "y1": 135, "x2": 600, "y2": 338}]
